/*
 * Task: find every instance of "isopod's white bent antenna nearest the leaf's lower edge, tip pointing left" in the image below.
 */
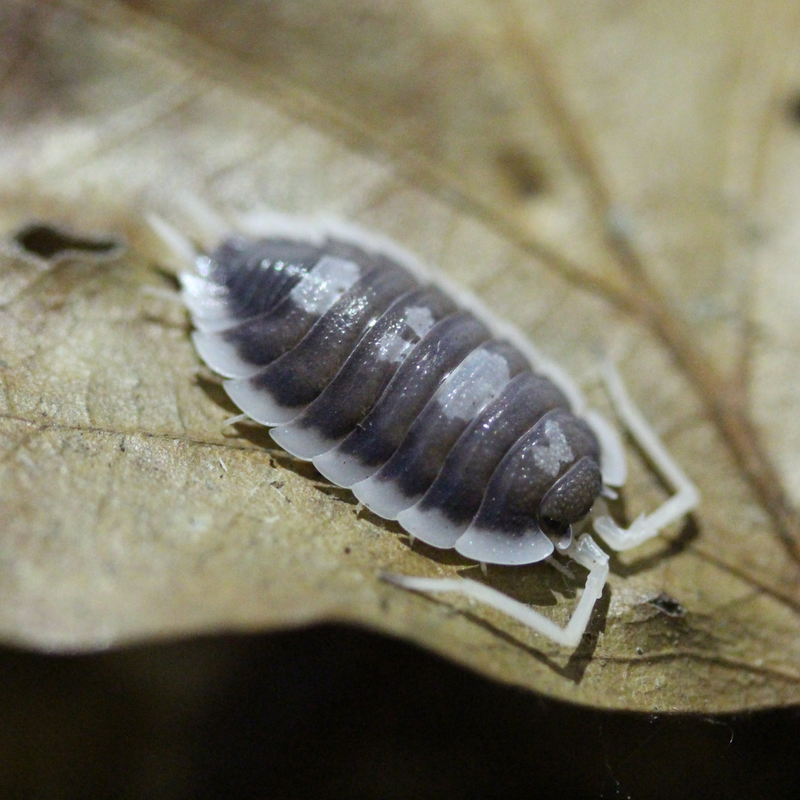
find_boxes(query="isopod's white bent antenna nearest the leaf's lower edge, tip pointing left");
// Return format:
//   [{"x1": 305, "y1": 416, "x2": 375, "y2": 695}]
[{"x1": 381, "y1": 534, "x2": 608, "y2": 647}]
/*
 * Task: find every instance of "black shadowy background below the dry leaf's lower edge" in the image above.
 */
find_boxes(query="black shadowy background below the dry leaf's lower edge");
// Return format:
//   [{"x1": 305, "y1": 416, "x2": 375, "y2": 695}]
[{"x1": 0, "y1": 625, "x2": 800, "y2": 799}]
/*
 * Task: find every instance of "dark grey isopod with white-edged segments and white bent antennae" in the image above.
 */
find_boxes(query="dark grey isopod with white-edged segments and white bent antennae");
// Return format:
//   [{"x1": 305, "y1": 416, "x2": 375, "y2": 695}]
[{"x1": 150, "y1": 202, "x2": 699, "y2": 647}]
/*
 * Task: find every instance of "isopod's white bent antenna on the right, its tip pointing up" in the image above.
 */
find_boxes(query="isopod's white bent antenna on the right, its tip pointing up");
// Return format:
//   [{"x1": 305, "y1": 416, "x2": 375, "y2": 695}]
[{"x1": 594, "y1": 361, "x2": 700, "y2": 550}]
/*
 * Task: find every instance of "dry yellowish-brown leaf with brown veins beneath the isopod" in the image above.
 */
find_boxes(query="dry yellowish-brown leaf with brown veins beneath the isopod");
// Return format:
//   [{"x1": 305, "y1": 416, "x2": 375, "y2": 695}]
[{"x1": 0, "y1": 0, "x2": 800, "y2": 712}]
